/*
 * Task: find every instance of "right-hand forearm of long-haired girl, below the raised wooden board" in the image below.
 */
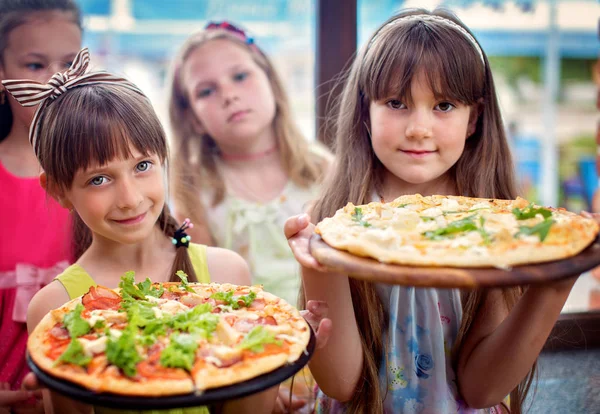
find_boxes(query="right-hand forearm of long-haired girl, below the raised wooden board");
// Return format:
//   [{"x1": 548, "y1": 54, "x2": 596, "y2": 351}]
[{"x1": 457, "y1": 278, "x2": 576, "y2": 408}]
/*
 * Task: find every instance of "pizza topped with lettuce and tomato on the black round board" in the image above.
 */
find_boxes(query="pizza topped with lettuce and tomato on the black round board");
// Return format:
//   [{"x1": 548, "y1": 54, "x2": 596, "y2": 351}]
[{"x1": 27, "y1": 272, "x2": 310, "y2": 396}]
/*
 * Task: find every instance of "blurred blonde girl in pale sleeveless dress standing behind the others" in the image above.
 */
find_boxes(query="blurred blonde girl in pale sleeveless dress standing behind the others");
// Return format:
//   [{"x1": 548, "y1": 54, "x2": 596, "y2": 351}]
[{"x1": 169, "y1": 22, "x2": 330, "y2": 410}]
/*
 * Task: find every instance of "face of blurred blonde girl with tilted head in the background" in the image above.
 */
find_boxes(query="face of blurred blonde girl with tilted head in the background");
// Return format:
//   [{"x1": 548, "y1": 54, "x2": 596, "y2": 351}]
[{"x1": 182, "y1": 39, "x2": 275, "y2": 153}]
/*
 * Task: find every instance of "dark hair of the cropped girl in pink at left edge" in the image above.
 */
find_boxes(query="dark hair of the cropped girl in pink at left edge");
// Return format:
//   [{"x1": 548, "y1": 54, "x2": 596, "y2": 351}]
[{"x1": 0, "y1": 0, "x2": 82, "y2": 141}]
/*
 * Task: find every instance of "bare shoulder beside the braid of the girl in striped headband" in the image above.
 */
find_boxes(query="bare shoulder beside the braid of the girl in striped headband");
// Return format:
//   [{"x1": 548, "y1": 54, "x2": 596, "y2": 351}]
[{"x1": 206, "y1": 247, "x2": 250, "y2": 285}]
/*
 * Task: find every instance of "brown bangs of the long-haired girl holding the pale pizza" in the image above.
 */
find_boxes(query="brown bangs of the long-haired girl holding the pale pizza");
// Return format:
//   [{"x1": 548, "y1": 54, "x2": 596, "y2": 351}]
[{"x1": 359, "y1": 17, "x2": 485, "y2": 105}]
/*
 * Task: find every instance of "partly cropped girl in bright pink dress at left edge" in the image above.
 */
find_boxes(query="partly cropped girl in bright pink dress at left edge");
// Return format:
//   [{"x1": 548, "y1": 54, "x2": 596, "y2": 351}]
[{"x1": 0, "y1": 0, "x2": 81, "y2": 411}]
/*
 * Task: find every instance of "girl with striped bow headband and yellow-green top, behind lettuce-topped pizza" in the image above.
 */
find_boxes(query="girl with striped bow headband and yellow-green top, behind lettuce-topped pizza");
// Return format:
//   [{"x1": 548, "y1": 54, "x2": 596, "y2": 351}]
[{"x1": 3, "y1": 49, "x2": 277, "y2": 413}]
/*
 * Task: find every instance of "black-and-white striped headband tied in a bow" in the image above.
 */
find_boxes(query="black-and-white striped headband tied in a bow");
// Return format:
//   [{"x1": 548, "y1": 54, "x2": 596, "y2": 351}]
[{"x1": 2, "y1": 48, "x2": 145, "y2": 155}]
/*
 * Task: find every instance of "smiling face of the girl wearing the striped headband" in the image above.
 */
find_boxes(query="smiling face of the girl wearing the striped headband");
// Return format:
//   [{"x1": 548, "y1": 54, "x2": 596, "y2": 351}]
[{"x1": 58, "y1": 147, "x2": 165, "y2": 244}]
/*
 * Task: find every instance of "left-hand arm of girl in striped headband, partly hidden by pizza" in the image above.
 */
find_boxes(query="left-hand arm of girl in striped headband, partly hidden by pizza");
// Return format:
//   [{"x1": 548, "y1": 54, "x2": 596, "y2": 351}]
[{"x1": 27, "y1": 281, "x2": 93, "y2": 414}]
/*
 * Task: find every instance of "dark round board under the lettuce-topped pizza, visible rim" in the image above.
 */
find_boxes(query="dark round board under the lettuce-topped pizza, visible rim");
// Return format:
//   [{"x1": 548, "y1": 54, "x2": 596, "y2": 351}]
[{"x1": 26, "y1": 329, "x2": 316, "y2": 410}]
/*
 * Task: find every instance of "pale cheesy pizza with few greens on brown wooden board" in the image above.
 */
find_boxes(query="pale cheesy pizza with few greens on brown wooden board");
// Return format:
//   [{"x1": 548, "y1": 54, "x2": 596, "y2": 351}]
[{"x1": 316, "y1": 194, "x2": 598, "y2": 268}]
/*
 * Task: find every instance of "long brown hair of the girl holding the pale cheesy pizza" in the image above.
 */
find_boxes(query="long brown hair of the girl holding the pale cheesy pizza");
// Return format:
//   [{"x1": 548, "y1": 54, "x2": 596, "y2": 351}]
[{"x1": 313, "y1": 10, "x2": 535, "y2": 413}]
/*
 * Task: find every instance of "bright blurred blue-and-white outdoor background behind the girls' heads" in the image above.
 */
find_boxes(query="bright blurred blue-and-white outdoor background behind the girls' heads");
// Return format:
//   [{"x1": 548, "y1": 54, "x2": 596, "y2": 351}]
[{"x1": 79, "y1": 0, "x2": 600, "y2": 211}]
